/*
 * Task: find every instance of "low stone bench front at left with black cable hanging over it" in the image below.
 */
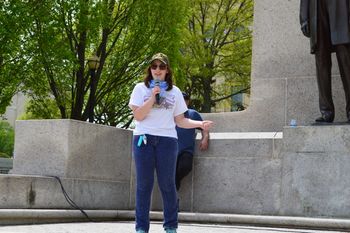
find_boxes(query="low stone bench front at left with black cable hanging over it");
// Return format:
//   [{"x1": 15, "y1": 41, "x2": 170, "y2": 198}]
[{"x1": 0, "y1": 174, "x2": 130, "y2": 210}]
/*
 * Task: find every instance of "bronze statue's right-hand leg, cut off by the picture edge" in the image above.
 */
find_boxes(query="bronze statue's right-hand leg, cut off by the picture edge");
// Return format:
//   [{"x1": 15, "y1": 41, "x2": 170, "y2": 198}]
[{"x1": 336, "y1": 44, "x2": 350, "y2": 121}]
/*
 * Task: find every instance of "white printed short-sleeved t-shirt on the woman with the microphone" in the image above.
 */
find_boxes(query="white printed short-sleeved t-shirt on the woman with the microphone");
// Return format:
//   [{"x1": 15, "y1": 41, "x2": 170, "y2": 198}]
[{"x1": 129, "y1": 83, "x2": 187, "y2": 138}]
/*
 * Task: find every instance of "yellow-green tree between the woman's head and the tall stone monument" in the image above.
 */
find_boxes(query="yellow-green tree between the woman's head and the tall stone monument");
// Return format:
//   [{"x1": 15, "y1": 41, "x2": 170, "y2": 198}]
[{"x1": 180, "y1": 0, "x2": 253, "y2": 112}]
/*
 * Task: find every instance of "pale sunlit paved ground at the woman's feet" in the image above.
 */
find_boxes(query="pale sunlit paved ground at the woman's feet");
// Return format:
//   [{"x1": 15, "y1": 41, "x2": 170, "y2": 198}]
[{"x1": 0, "y1": 222, "x2": 350, "y2": 233}]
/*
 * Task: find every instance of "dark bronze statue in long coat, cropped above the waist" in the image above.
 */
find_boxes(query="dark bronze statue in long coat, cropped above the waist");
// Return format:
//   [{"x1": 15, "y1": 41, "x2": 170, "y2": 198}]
[{"x1": 300, "y1": 0, "x2": 350, "y2": 123}]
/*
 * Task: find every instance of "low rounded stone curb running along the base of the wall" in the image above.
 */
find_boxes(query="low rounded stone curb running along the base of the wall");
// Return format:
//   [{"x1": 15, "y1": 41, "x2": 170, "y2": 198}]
[{"x1": 0, "y1": 209, "x2": 350, "y2": 230}]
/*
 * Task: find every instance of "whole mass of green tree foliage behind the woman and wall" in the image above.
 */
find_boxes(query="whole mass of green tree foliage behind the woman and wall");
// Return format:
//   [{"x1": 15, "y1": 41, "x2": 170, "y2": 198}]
[{"x1": 0, "y1": 0, "x2": 253, "y2": 127}]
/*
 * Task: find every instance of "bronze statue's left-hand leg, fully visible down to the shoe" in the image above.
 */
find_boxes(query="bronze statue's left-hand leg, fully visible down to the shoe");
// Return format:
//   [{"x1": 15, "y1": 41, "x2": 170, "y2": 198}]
[{"x1": 315, "y1": 1, "x2": 334, "y2": 122}]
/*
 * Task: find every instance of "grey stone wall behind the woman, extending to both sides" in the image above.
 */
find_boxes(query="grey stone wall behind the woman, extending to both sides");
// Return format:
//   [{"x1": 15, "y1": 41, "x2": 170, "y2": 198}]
[{"x1": 6, "y1": 120, "x2": 350, "y2": 218}]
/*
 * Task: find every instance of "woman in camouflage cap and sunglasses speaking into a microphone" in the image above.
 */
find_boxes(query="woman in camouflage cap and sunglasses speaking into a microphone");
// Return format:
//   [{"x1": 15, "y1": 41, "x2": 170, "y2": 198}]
[{"x1": 129, "y1": 53, "x2": 213, "y2": 233}]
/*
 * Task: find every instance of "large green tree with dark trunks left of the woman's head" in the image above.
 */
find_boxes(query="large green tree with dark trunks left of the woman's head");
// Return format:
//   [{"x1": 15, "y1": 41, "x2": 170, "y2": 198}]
[{"x1": 2, "y1": 0, "x2": 186, "y2": 125}]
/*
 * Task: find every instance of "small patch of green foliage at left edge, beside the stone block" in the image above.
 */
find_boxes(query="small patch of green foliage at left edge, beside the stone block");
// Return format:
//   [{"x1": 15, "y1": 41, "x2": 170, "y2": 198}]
[{"x1": 0, "y1": 121, "x2": 15, "y2": 158}]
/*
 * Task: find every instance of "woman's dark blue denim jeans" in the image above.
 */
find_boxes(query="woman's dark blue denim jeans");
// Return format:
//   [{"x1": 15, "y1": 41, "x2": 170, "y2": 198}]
[{"x1": 133, "y1": 134, "x2": 178, "y2": 232}]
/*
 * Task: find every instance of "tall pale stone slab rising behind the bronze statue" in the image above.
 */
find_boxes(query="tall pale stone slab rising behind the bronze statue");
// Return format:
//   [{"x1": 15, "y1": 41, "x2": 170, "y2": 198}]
[{"x1": 207, "y1": 0, "x2": 347, "y2": 132}]
